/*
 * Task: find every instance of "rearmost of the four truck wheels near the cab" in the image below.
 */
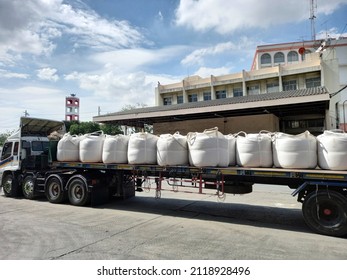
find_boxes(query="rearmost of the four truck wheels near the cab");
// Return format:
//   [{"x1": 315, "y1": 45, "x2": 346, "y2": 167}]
[{"x1": 68, "y1": 176, "x2": 90, "y2": 206}]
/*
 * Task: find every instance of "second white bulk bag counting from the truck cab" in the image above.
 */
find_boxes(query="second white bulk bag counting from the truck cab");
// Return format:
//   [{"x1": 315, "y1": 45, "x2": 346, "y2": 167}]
[{"x1": 80, "y1": 131, "x2": 105, "y2": 162}]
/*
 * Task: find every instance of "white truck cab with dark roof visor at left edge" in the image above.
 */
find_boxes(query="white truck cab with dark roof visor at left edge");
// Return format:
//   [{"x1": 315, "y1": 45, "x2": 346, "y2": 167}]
[{"x1": 0, "y1": 117, "x2": 65, "y2": 196}]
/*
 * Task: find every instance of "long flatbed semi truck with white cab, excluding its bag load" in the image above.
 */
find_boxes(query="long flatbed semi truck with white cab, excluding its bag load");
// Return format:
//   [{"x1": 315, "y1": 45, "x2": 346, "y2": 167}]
[{"x1": 0, "y1": 117, "x2": 347, "y2": 236}]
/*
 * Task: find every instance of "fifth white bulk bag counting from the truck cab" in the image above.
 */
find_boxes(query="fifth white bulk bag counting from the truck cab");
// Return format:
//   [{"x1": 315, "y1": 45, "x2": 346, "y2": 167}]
[{"x1": 157, "y1": 132, "x2": 188, "y2": 166}]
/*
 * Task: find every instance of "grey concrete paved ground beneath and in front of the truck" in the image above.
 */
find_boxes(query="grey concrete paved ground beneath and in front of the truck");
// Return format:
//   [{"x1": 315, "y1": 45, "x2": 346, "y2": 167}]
[{"x1": 0, "y1": 185, "x2": 347, "y2": 260}]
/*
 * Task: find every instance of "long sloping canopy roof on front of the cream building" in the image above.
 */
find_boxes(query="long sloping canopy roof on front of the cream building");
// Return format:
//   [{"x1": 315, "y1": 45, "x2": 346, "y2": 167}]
[{"x1": 93, "y1": 87, "x2": 330, "y2": 127}]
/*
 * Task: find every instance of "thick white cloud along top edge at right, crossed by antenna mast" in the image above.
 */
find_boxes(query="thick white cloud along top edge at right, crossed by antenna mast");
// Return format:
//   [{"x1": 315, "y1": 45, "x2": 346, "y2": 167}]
[{"x1": 176, "y1": 0, "x2": 347, "y2": 34}]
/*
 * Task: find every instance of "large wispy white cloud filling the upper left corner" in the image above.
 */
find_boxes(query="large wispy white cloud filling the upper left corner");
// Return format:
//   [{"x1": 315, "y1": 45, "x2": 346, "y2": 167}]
[{"x1": 0, "y1": 0, "x2": 145, "y2": 63}]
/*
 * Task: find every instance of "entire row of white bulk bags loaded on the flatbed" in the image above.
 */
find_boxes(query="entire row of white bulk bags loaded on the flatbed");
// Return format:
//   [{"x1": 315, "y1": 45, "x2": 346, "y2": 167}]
[{"x1": 57, "y1": 128, "x2": 347, "y2": 170}]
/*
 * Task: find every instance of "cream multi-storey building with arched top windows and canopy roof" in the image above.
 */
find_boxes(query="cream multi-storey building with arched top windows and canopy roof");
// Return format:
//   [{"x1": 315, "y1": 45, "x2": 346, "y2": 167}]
[{"x1": 94, "y1": 38, "x2": 347, "y2": 134}]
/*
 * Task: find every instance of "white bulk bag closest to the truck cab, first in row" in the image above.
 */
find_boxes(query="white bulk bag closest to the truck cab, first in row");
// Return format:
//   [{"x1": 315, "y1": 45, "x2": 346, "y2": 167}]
[{"x1": 57, "y1": 132, "x2": 82, "y2": 161}]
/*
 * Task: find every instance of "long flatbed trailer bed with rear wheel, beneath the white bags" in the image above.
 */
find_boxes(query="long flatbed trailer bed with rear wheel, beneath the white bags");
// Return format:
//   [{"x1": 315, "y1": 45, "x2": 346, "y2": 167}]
[{"x1": 52, "y1": 162, "x2": 347, "y2": 236}]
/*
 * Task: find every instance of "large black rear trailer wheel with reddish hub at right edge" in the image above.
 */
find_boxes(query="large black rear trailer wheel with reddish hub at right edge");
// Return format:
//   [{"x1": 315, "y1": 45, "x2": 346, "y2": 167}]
[{"x1": 302, "y1": 191, "x2": 347, "y2": 236}]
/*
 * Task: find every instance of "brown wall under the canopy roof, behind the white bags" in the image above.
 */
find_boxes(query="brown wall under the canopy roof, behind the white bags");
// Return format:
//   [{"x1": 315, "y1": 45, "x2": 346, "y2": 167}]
[{"x1": 153, "y1": 114, "x2": 279, "y2": 135}]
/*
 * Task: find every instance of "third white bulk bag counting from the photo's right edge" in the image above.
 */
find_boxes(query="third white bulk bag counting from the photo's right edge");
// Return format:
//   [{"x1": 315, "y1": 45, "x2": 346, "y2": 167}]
[{"x1": 236, "y1": 131, "x2": 273, "y2": 167}]
